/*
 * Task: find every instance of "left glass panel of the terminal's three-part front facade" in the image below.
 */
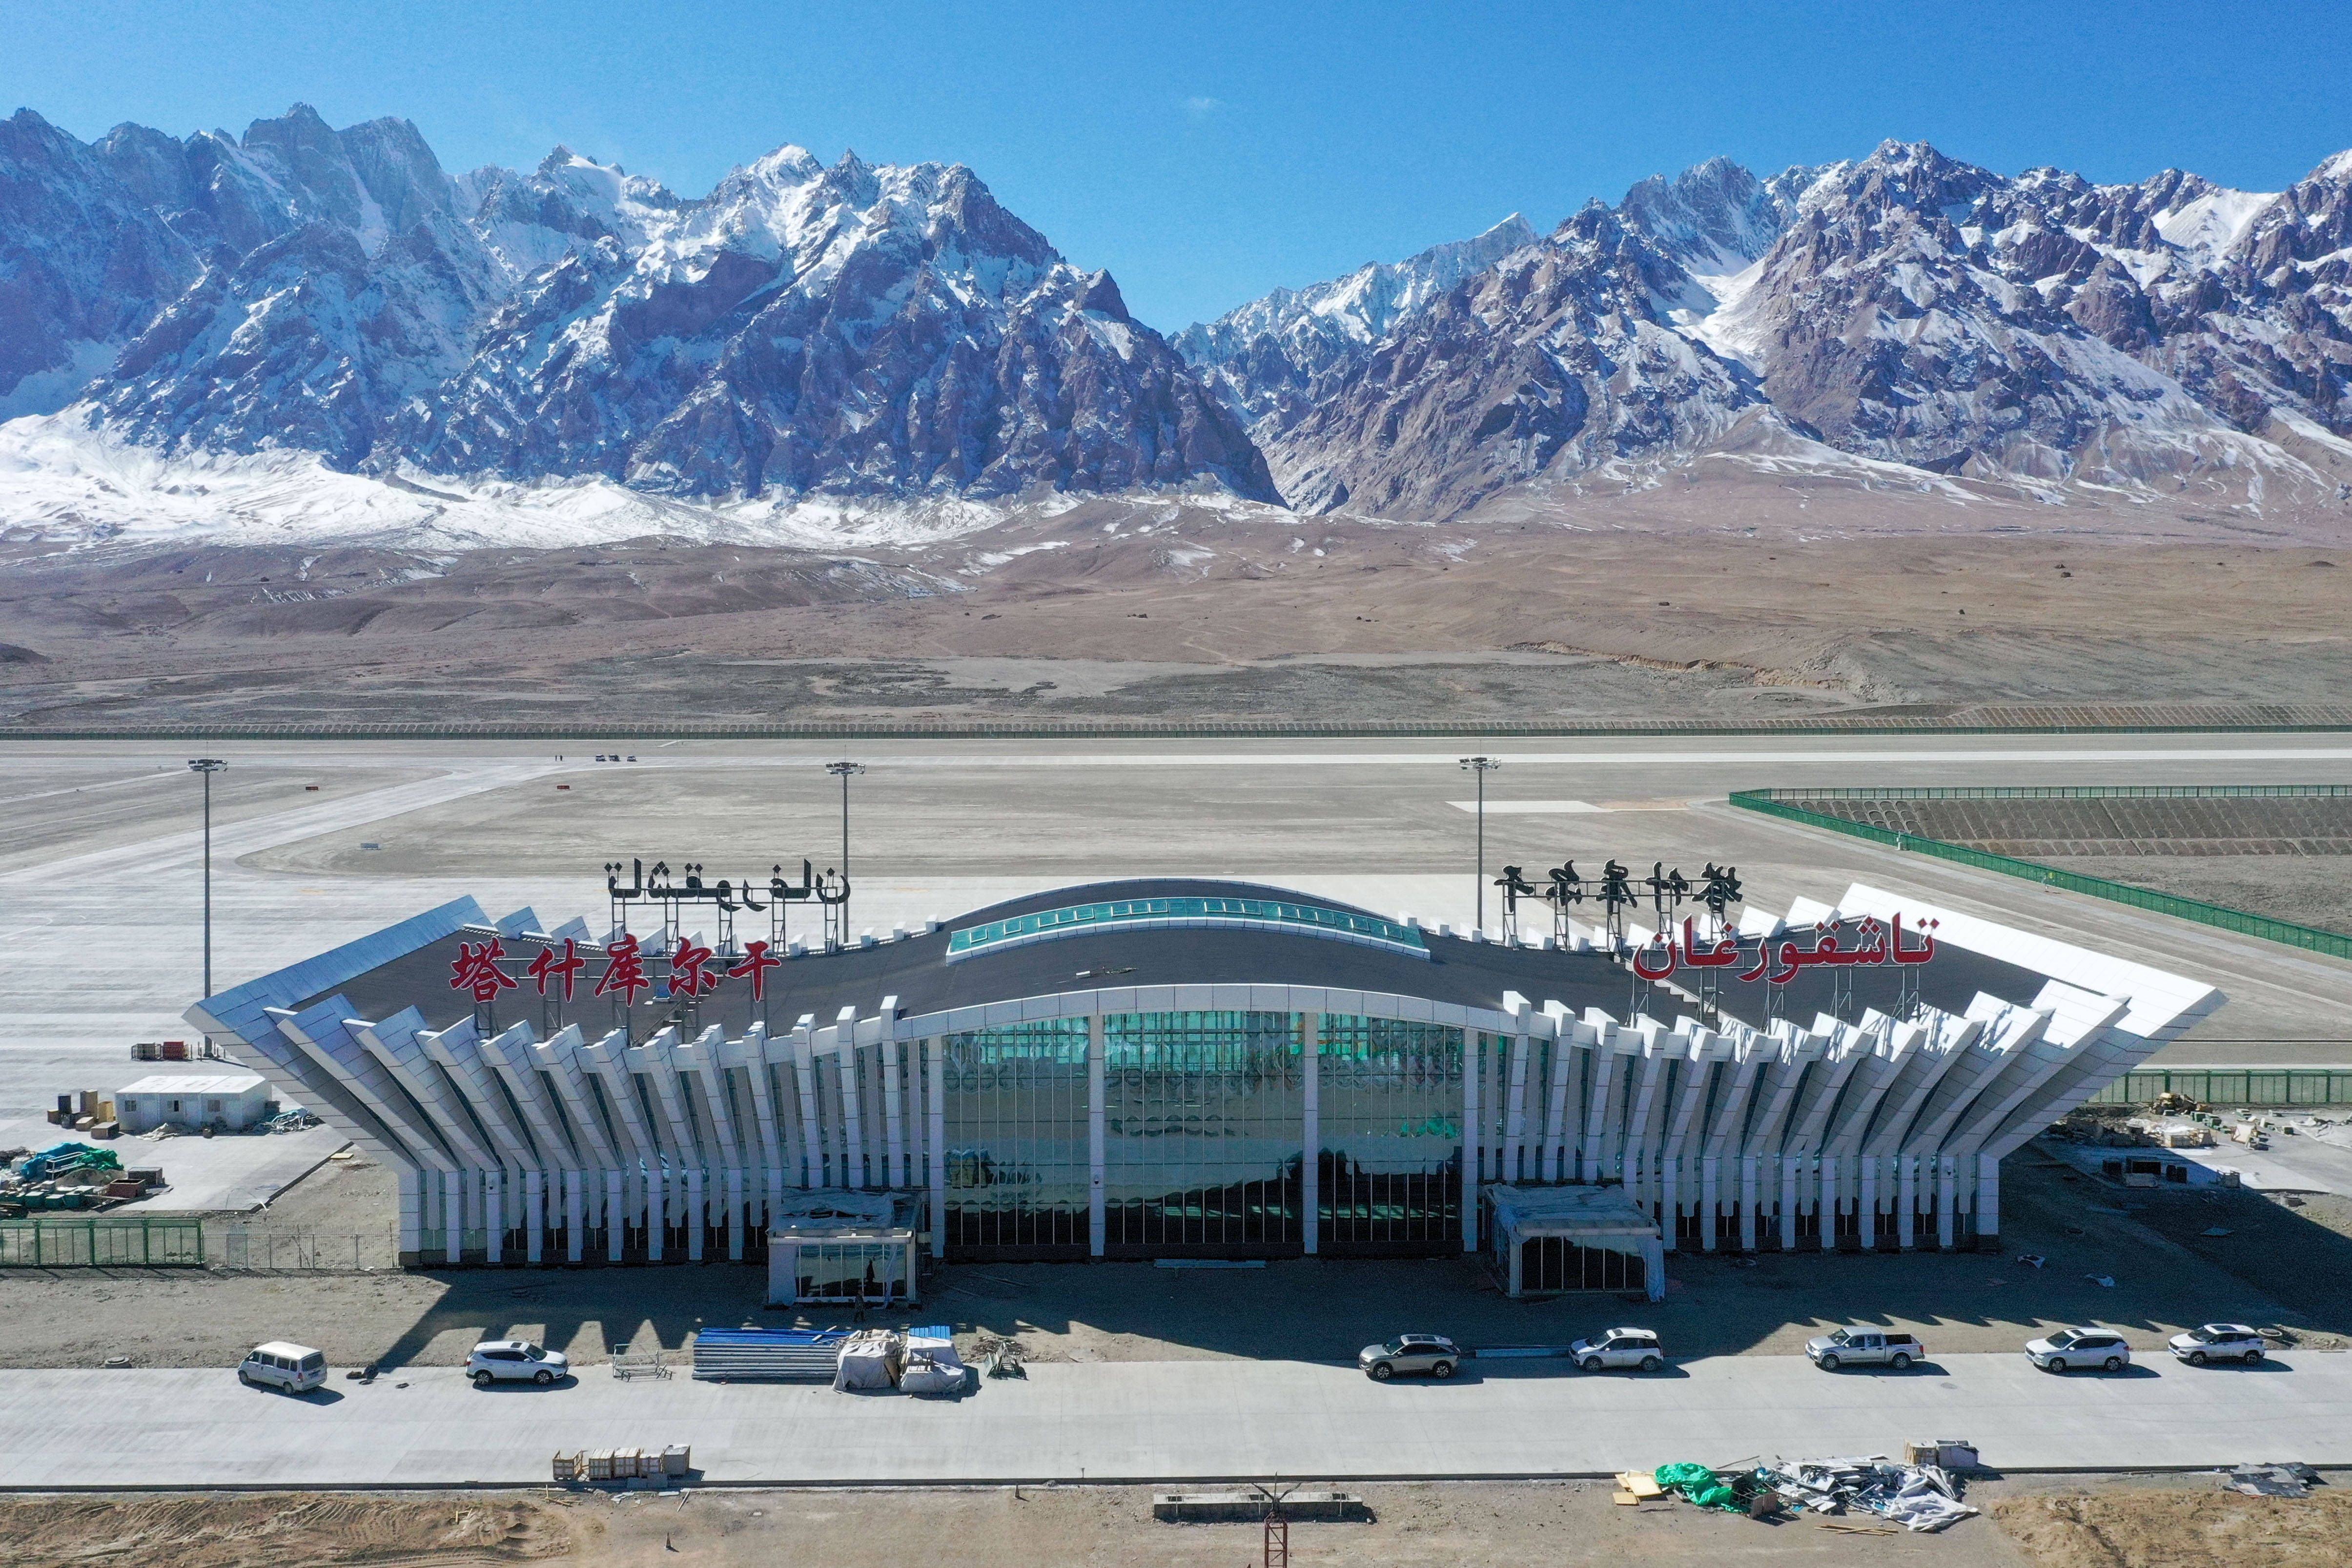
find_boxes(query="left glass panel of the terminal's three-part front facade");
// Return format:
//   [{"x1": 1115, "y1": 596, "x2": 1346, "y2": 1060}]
[{"x1": 943, "y1": 1018, "x2": 1091, "y2": 1260}]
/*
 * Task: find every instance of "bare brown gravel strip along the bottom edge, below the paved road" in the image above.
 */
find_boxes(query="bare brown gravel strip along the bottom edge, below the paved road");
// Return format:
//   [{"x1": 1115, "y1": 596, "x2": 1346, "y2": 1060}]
[{"x1": 18, "y1": 1476, "x2": 2352, "y2": 1568}]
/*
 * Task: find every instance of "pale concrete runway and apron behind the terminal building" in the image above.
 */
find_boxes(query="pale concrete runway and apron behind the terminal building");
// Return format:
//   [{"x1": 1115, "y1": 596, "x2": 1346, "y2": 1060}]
[{"x1": 0, "y1": 736, "x2": 2352, "y2": 1114}]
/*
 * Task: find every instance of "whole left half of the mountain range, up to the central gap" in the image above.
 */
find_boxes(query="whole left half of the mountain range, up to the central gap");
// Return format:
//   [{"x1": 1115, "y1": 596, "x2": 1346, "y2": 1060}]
[{"x1": 0, "y1": 106, "x2": 1275, "y2": 531}]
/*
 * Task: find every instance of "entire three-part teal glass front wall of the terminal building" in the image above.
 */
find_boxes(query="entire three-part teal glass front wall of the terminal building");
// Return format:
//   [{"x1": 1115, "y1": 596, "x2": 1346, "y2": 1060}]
[{"x1": 943, "y1": 1011, "x2": 1468, "y2": 1260}]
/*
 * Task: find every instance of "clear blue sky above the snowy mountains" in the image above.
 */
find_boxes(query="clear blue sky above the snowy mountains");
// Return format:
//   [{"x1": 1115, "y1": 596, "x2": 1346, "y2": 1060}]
[{"x1": 0, "y1": 0, "x2": 2352, "y2": 329}]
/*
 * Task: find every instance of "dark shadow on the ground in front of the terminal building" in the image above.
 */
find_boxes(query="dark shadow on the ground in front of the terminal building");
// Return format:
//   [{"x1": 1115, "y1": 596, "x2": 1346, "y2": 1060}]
[{"x1": 336, "y1": 1147, "x2": 2352, "y2": 1378}]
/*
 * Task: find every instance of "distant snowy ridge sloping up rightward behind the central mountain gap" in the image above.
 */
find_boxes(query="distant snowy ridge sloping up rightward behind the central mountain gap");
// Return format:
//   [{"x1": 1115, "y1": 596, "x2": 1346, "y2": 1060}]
[{"x1": 1169, "y1": 212, "x2": 1536, "y2": 440}]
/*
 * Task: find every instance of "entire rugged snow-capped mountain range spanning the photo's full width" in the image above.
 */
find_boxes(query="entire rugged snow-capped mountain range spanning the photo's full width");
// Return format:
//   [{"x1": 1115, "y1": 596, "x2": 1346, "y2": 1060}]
[{"x1": 0, "y1": 106, "x2": 2352, "y2": 541}]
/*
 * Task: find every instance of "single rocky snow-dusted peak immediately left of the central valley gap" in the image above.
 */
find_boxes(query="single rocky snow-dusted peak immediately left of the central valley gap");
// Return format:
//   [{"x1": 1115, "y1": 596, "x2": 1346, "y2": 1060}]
[{"x1": 393, "y1": 148, "x2": 1272, "y2": 498}]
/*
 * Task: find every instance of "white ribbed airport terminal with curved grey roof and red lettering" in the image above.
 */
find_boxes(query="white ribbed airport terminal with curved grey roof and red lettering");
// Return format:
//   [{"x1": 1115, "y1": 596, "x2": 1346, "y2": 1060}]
[{"x1": 188, "y1": 879, "x2": 2223, "y2": 1295}]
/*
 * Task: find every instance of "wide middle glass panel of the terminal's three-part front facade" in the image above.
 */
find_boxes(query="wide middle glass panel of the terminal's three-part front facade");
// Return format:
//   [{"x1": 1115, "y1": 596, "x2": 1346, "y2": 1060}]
[{"x1": 1103, "y1": 1011, "x2": 1306, "y2": 1258}]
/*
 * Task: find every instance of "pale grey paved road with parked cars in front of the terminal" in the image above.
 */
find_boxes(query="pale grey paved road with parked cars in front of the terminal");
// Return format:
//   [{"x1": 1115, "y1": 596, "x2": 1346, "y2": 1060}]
[{"x1": 0, "y1": 1352, "x2": 2352, "y2": 1488}]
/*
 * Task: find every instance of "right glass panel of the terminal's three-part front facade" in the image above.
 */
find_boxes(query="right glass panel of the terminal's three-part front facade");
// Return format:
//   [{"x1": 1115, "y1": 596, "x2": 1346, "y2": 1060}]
[{"x1": 1317, "y1": 1013, "x2": 1463, "y2": 1255}]
